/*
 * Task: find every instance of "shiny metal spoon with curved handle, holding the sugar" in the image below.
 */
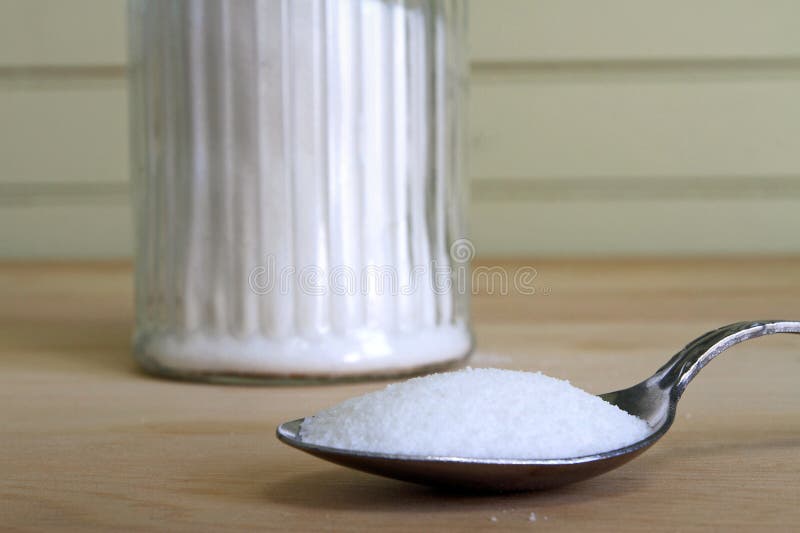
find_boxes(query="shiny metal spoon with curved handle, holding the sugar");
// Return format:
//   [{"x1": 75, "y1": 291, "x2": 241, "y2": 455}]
[{"x1": 276, "y1": 320, "x2": 800, "y2": 491}]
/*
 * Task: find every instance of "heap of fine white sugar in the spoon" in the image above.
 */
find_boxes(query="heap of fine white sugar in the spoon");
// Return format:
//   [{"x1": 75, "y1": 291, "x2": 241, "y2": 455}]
[{"x1": 300, "y1": 368, "x2": 650, "y2": 459}]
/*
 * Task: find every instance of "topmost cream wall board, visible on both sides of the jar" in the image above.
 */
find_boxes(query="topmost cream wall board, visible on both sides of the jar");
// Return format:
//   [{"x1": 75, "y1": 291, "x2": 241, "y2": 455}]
[{"x1": 0, "y1": 0, "x2": 800, "y2": 67}]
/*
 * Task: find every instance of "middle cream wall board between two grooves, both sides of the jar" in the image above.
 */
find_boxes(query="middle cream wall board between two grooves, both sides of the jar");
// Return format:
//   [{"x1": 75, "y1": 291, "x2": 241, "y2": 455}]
[{"x1": 0, "y1": 79, "x2": 800, "y2": 188}]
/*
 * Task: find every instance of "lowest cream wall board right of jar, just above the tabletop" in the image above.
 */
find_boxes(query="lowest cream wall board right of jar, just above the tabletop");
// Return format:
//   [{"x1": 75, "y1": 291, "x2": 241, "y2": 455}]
[{"x1": 471, "y1": 197, "x2": 800, "y2": 258}]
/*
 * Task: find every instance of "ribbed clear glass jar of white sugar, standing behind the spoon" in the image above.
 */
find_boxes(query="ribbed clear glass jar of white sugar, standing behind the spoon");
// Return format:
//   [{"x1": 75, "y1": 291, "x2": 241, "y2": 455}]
[{"x1": 129, "y1": 0, "x2": 472, "y2": 380}]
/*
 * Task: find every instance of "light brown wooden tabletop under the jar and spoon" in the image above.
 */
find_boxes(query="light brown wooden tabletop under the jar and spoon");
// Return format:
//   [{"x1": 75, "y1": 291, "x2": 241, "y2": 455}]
[{"x1": 0, "y1": 258, "x2": 800, "y2": 532}]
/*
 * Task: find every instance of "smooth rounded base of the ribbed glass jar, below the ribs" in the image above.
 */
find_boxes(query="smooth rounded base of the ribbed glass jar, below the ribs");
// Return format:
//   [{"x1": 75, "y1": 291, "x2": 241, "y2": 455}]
[{"x1": 134, "y1": 326, "x2": 473, "y2": 384}]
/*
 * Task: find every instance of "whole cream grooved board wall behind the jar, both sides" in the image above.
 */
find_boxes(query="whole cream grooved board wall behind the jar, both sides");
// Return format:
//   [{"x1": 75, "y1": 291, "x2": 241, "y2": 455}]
[{"x1": 0, "y1": 0, "x2": 800, "y2": 258}]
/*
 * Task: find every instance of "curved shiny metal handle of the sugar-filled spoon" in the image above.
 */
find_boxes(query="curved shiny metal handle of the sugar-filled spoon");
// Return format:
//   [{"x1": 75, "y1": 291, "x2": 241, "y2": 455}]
[{"x1": 656, "y1": 320, "x2": 800, "y2": 400}]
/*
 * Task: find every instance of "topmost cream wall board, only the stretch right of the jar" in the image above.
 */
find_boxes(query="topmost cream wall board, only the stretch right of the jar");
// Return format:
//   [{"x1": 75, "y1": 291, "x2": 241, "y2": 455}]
[{"x1": 470, "y1": 0, "x2": 800, "y2": 63}]
